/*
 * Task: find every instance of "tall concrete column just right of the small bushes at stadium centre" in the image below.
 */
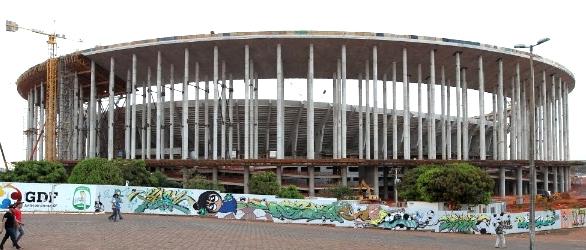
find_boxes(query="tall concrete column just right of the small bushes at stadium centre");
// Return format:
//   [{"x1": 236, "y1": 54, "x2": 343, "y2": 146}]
[{"x1": 306, "y1": 44, "x2": 315, "y2": 197}]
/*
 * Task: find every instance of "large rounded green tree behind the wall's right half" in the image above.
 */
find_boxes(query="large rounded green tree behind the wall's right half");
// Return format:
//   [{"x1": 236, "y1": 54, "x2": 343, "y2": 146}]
[{"x1": 416, "y1": 163, "x2": 494, "y2": 207}]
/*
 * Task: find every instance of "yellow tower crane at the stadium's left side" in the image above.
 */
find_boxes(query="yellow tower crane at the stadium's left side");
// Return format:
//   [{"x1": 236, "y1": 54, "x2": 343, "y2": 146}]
[{"x1": 6, "y1": 20, "x2": 81, "y2": 161}]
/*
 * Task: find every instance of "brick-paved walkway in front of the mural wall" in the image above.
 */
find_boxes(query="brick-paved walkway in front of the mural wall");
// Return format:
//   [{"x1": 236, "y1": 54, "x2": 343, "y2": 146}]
[{"x1": 5, "y1": 214, "x2": 586, "y2": 250}]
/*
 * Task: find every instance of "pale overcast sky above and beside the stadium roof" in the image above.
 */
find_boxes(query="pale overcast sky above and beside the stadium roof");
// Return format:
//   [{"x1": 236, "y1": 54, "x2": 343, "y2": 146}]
[{"x1": 0, "y1": 0, "x2": 586, "y2": 161}]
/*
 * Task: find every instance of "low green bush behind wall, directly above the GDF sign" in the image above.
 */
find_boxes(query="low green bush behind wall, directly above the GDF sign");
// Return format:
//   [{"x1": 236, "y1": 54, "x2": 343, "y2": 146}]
[{"x1": 0, "y1": 161, "x2": 67, "y2": 183}]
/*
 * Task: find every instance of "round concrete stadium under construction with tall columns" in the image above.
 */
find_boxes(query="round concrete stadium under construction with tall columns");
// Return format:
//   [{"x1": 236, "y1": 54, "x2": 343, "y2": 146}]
[{"x1": 17, "y1": 31, "x2": 583, "y2": 197}]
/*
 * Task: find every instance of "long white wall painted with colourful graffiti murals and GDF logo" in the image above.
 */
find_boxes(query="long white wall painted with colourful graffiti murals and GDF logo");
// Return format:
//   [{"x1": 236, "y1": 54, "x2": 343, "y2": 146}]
[{"x1": 0, "y1": 182, "x2": 586, "y2": 234}]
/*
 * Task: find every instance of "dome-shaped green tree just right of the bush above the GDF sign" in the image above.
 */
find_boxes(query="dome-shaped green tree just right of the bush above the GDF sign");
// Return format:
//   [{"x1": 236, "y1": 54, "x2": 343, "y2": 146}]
[{"x1": 68, "y1": 158, "x2": 124, "y2": 185}]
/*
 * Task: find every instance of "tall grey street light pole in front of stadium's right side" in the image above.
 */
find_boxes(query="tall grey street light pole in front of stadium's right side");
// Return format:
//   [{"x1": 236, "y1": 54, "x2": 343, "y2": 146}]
[{"x1": 515, "y1": 38, "x2": 549, "y2": 250}]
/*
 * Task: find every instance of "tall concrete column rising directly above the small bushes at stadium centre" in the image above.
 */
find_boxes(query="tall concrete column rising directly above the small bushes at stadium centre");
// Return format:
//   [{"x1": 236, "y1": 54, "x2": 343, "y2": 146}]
[{"x1": 277, "y1": 44, "x2": 285, "y2": 159}]
